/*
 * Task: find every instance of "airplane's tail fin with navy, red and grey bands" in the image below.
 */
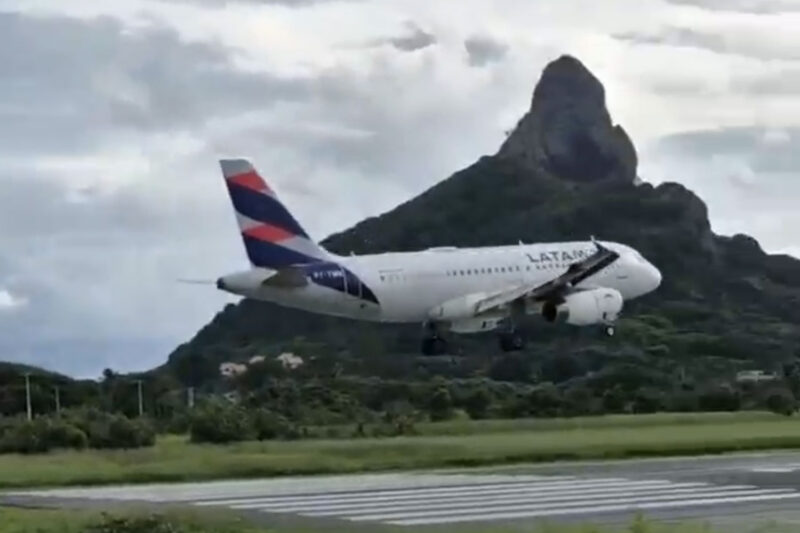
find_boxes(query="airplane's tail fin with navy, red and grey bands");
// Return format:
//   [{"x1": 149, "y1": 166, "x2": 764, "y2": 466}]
[{"x1": 220, "y1": 159, "x2": 328, "y2": 270}]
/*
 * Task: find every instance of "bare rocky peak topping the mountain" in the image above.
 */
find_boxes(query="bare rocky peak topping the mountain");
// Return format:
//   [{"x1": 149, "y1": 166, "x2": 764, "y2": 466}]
[{"x1": 497, "y1": 55, "x2": 638, "y2": 183}]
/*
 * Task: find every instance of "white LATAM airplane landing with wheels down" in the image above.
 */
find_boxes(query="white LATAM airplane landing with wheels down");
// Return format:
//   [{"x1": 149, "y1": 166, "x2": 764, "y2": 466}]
[{"x1": 216, "y1": 159, "x2": 661, "y2": 355}]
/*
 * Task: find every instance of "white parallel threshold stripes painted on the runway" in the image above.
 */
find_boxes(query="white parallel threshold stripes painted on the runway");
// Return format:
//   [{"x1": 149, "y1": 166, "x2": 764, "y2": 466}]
[{"x1": 186, "y1": 475, "x2": 800, "y2": 526}]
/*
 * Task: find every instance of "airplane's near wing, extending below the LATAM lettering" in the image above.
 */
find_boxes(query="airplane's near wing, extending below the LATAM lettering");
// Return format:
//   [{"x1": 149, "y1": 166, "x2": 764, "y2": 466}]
[{"x1": 475, "y1": 241, "x2": 619, "y2": 315}]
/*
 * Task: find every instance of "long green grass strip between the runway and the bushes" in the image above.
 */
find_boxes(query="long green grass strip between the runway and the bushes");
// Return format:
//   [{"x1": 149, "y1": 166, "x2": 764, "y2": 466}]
[{"x1": 0, "y1": 413, "x2": 800, "y2": 488}]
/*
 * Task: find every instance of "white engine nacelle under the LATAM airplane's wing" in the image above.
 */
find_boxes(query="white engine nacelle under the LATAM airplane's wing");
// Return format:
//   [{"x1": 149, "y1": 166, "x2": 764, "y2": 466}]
[{"x1": 542, "y1": 288, "x2": 623, "y2": 326}]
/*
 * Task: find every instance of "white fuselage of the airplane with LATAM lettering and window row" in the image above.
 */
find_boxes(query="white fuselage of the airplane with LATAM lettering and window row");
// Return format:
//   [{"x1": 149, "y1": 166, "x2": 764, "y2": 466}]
[{"x1": 222, "y1": 242, "x2": 661, "y2": 323}]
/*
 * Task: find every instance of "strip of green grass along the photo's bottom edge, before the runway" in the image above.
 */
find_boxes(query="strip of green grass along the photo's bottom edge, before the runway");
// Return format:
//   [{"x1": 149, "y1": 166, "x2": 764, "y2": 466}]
[{"x1": 0, "y1": 507, "x2": 795, "y2": 533}]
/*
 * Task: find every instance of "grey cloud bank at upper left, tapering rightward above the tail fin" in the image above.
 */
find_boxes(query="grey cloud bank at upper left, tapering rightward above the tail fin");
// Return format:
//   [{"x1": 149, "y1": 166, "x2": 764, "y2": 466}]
[{"x1": 0, "y1": 13, "x2": 312, "y2": 158}]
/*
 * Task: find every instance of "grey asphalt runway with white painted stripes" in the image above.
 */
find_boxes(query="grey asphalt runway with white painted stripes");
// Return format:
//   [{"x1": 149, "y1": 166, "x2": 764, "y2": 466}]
[{"x1": 7, "y1": 453, "x2": 800, "y2": 531}]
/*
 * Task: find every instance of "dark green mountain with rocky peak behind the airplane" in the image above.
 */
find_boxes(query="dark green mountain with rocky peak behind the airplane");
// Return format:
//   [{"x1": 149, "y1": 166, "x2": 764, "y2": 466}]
[{"x1": 165, "y1": 56, "x2": 800, "y2": 384}]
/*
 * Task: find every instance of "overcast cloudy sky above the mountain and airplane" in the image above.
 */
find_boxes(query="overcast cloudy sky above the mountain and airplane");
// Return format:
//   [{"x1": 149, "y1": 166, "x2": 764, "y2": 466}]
[{"x1": 0, "y1": 0, "x2": 800, "y2": 376}]
